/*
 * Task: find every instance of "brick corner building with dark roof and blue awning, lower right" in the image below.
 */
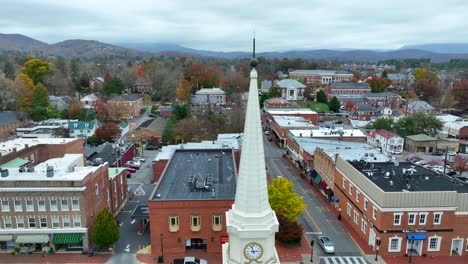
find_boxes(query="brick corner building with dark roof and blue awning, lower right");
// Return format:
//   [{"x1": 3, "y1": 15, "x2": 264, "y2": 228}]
[{"x1": 334, "y1": 156, "x2": 468, "y2": 257}]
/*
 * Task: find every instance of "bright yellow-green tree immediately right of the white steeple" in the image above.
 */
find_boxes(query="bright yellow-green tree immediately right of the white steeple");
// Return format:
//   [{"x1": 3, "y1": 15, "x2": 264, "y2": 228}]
[{"x1": 268, "y1": 177, "x2": 306, "y2": 221}]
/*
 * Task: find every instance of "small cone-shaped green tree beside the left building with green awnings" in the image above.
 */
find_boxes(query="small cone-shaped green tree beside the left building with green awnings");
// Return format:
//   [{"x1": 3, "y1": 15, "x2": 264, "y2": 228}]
[{"x1": 91, "y1": 207, "x2": 120, "y2": 247}]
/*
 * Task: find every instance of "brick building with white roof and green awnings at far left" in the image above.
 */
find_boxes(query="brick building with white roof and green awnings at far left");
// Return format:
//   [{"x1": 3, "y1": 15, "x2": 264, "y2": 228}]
[{"x1": 0, "y1": 154, "x2": 126, "y2": 252}]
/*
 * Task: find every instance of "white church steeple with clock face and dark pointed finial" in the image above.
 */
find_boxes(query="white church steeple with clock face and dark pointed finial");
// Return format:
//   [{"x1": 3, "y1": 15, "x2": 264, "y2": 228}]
[{"x1": 223, "y1": 37, "x2": 280, "y2": 264}]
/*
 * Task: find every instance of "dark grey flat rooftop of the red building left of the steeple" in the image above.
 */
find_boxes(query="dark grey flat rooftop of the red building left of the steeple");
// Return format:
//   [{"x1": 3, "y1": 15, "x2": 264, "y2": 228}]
[{"x1": 151, "y1": 149, "x2": 236, "y2": 200}]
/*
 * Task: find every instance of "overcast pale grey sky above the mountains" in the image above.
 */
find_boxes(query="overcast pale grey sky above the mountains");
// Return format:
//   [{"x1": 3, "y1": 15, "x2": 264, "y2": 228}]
[{"x1": 0, "y1": 0, "x2": 468, "y2": 52}]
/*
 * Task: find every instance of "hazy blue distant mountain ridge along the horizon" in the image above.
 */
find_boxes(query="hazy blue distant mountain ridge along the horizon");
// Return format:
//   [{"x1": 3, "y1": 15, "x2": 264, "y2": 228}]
[{"x1": 0, "y1": 33, "x2": 468, "y2": 62}]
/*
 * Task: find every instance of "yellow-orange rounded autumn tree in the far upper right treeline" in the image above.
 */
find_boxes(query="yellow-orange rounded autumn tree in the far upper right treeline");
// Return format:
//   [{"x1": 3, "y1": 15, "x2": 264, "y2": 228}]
[{"x1": 413, "y1": 68, "x2": 439, "y2": 100}]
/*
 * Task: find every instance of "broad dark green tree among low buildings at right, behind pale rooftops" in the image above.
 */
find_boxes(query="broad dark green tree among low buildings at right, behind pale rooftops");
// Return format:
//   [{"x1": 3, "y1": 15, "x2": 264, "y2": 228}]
[{"x1": 393, "y1": 112, "x2": 442, "y2": 137}]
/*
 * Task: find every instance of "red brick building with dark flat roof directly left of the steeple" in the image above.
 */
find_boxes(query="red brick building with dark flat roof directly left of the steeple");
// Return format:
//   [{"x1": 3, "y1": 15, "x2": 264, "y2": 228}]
[{"x1": 148, "y1": 148, "x2": 237, "y2": 256}]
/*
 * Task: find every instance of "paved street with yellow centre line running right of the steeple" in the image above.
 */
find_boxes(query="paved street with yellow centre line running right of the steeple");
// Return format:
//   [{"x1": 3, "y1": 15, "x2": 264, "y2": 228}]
[{"x1": 264, "y1": 137, "x2": 362, "y2": 263}]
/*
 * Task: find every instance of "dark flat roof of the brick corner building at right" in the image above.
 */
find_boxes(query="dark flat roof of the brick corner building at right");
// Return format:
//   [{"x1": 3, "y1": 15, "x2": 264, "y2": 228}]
[{"x1": 348, "y1": 160, "x2": 468, "y2": 193}]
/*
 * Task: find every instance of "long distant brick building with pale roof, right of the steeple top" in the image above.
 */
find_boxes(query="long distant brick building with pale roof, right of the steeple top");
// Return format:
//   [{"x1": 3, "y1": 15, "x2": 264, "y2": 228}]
[{"x1": 289, "y1": 70, "x2": 353, "y2": 86}]
